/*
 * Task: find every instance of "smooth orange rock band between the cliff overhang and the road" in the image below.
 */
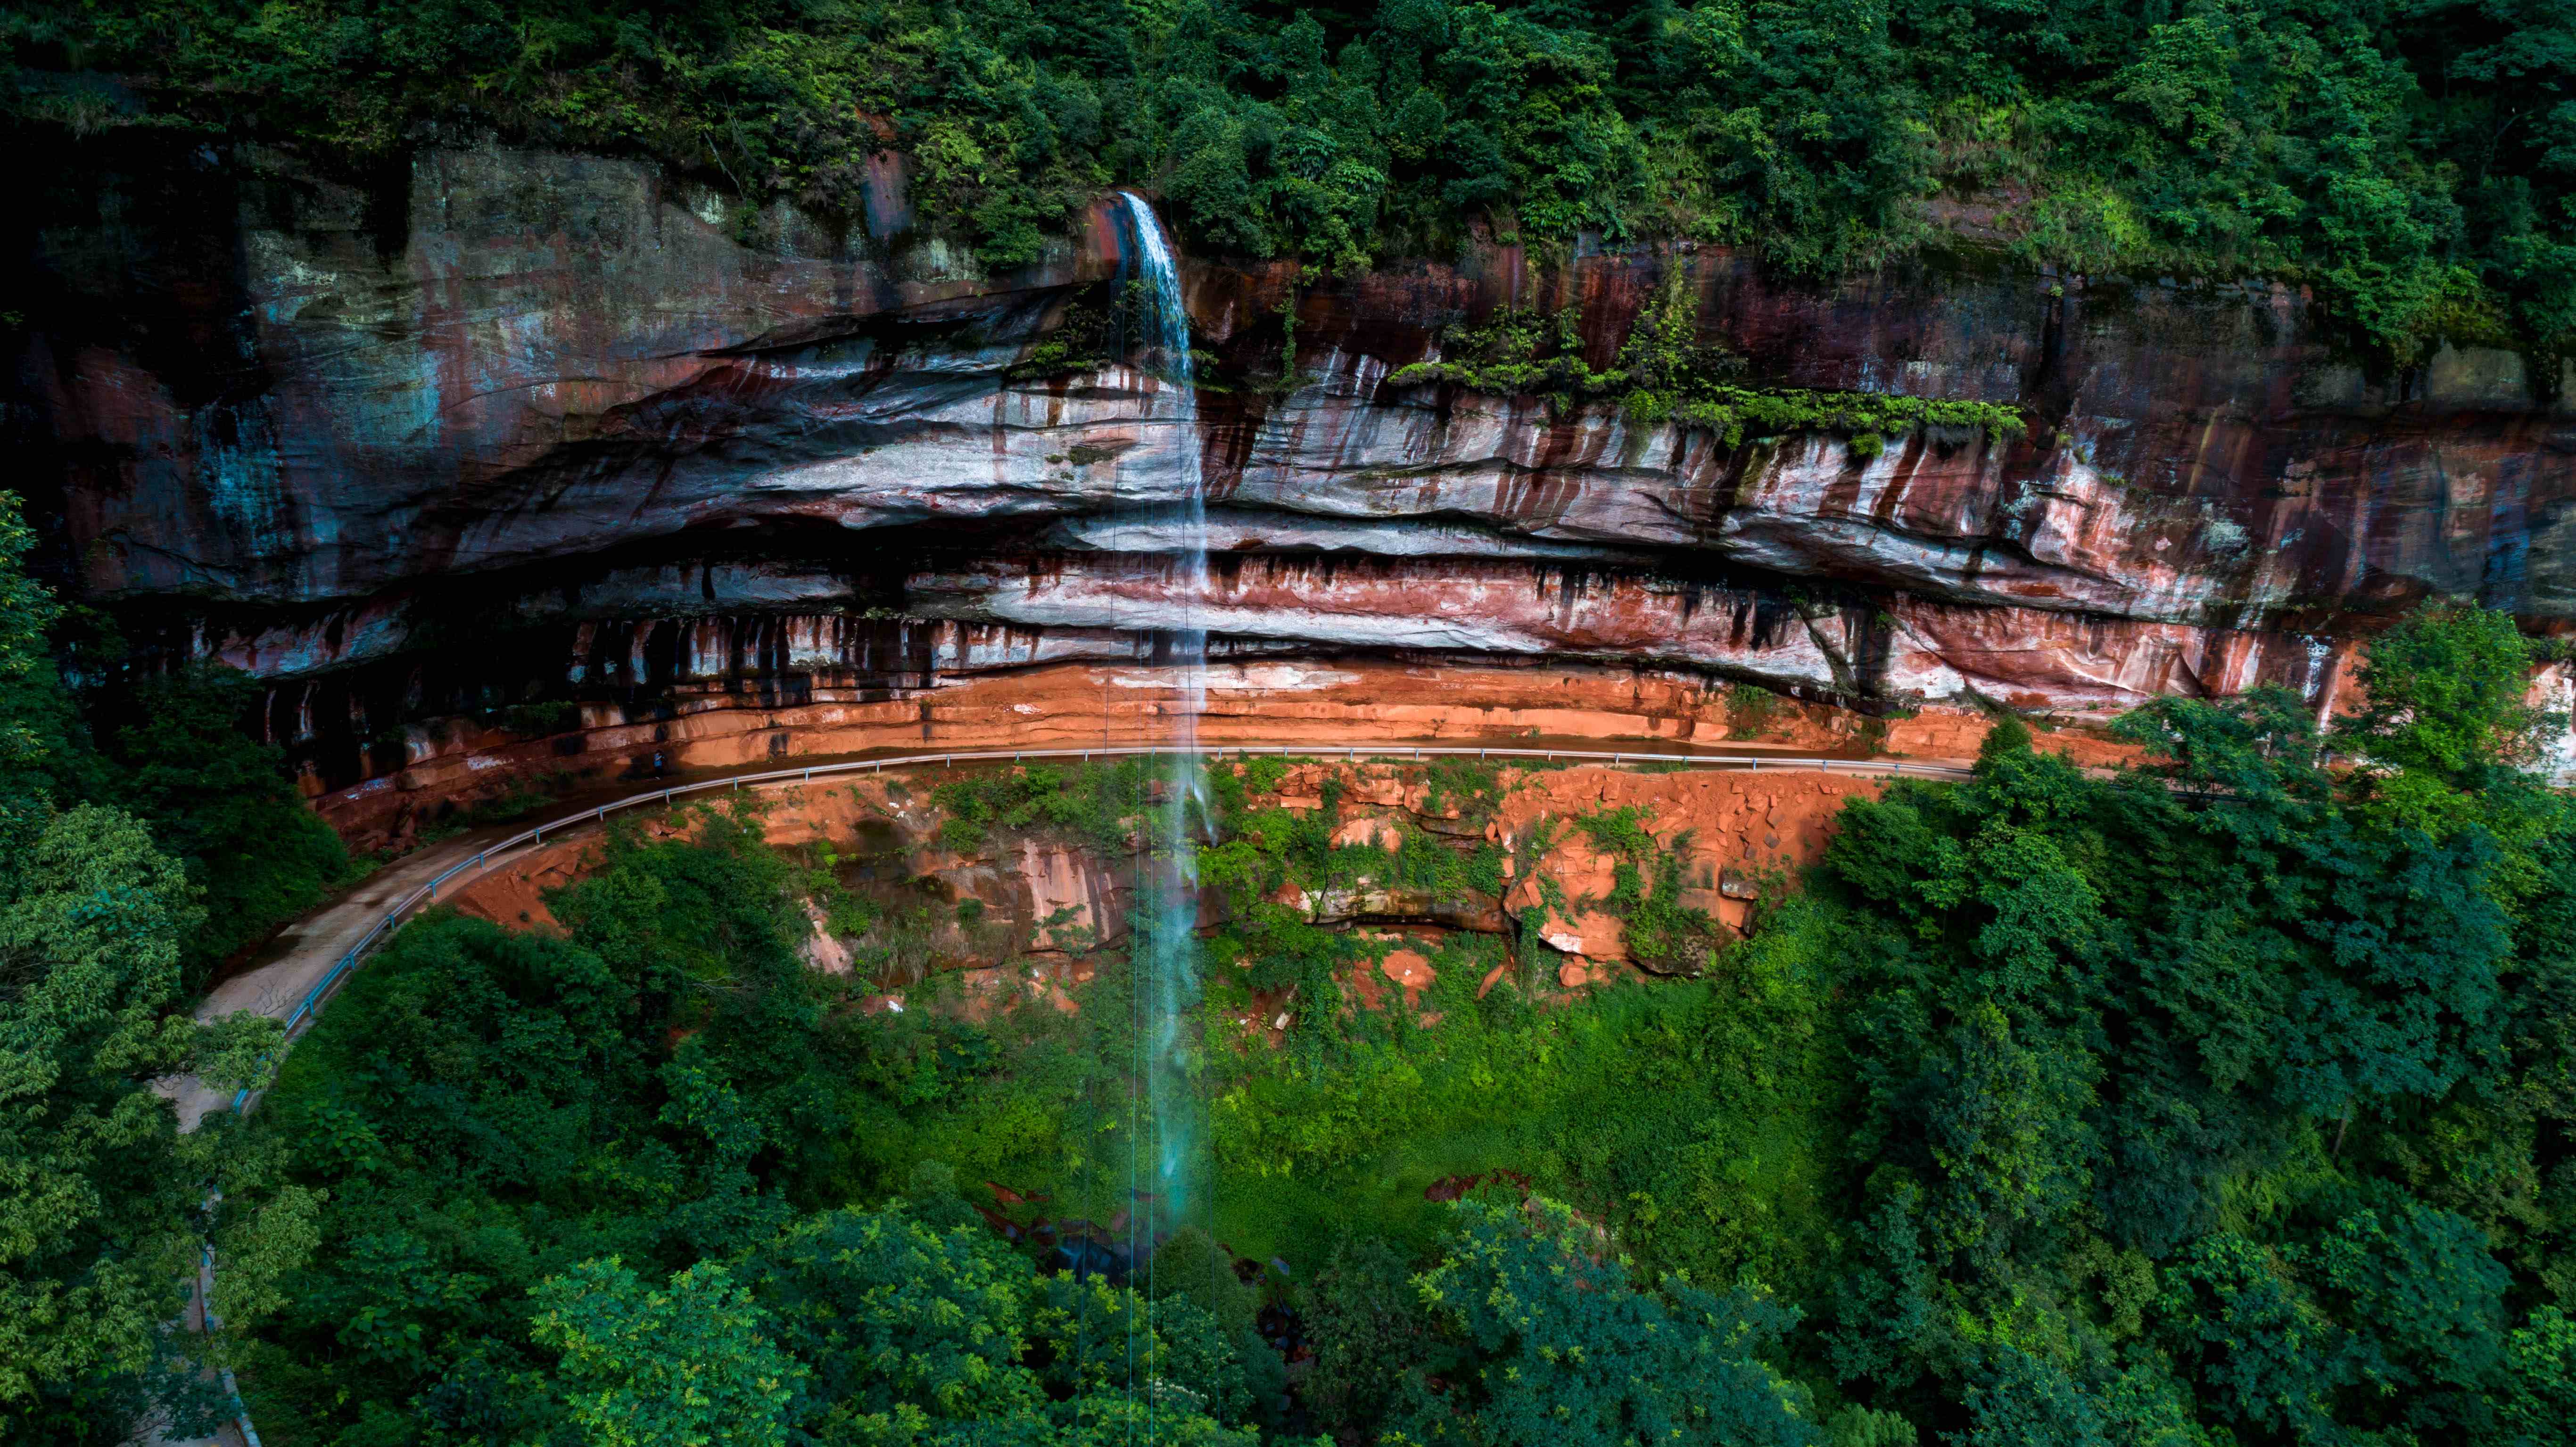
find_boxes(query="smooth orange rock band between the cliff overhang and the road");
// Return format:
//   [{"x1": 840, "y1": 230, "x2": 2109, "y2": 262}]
[{"x1": 312, "y1": 659, "x2": 1906, "y2": 847}]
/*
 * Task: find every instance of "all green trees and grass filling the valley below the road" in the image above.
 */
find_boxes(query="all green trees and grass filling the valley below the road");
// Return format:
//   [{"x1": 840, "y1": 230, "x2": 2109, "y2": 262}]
[{"x1": 0, "y1": 589, "x2": 2576, "y2": 1447}]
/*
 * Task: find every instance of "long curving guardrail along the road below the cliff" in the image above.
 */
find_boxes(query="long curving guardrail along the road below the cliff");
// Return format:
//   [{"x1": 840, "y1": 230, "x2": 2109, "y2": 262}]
[{"x1": 232, "y1": 744, "x2": 1973, "y2": 1110}]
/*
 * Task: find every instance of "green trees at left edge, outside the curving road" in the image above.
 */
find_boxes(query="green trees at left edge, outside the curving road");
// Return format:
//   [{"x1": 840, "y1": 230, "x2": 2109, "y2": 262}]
[{"x1": 0, "y1": 494, "x2": 332, "y2": 1442}]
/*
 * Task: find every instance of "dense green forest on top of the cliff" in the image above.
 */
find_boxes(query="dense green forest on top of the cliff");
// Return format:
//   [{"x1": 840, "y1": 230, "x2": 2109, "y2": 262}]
[{"x1": 0, "y1": 0, "x2": 2576, "y2": 353}]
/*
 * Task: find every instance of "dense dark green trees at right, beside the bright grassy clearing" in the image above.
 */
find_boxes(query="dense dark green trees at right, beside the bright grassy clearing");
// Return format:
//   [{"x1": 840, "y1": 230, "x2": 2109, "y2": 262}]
[{"x1": 1826, "y1": 608, "x2": 2576, "y2": 1445}]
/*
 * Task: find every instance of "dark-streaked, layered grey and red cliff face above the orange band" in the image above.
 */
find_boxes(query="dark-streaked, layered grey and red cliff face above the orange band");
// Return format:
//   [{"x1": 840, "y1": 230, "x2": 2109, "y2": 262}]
[{"x1": 18, "y1": 149, "x2": 2576, "y2": 824}]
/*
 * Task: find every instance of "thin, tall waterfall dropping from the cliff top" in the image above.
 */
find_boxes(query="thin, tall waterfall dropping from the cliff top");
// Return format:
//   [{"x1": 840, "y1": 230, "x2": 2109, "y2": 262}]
[{"x1": 1118, "y1": 190, "x2": 1208, "y2": 1249}]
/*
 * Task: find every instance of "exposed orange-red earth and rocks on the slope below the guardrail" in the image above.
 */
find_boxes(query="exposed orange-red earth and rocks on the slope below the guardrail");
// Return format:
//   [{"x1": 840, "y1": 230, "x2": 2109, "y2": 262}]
[{"x1": 448, "y1": 759, "x2": 1927, "y2": 999}]
